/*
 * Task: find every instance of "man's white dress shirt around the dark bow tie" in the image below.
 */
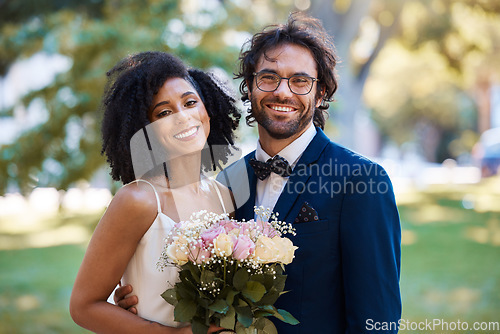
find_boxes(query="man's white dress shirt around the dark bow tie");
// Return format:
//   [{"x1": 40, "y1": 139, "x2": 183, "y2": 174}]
[{"x1": 255, "y1": 123, "x2": 316, "y2": 219}]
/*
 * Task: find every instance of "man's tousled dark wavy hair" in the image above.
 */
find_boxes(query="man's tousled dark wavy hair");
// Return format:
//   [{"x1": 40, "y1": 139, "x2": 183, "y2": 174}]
[{"x1": 235, "y1": 12, "x2": 338, "y2": 129}]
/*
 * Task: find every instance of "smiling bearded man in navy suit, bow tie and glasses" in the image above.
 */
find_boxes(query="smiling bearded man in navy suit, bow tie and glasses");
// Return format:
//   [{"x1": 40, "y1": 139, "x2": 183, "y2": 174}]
[{"x1": 115, "y1": 14, "x2": 401, "y2": 334}]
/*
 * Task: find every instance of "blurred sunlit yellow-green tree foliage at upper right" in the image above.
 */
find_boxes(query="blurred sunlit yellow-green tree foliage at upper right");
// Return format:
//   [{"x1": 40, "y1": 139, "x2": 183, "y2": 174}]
[{"x1": 364, "y1": 0, "x2": 500, "y2": 161}]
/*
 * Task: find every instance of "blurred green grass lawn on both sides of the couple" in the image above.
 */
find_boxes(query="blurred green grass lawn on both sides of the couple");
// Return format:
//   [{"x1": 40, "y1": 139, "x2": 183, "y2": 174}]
[{"x1": 0, "y1": 179, "x2": 500, "y2": 334}]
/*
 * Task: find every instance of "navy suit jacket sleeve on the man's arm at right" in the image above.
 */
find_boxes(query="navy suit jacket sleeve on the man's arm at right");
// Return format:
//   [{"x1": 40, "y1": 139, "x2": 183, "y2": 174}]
[{"x1": 340, "y1": 164, "x2": 401, "y2": 334}]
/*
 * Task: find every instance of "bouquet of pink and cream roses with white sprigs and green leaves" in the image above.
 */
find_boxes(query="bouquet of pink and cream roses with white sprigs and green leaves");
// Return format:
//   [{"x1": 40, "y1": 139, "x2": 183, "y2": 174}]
[{"x1": 158, "y1": 207, "x2": 298, "y2": 334}]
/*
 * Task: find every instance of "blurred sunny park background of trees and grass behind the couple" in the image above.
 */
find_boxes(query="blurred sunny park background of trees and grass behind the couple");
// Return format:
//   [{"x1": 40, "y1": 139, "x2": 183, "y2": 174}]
[{"x1": 0, "y1": 0, "x2": 500, "y2": 333}]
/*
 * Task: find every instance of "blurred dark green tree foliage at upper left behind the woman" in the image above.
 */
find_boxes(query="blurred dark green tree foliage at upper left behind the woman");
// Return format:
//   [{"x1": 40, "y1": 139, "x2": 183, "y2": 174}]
[{"x1": 0, "y1": 0, "x2": 296, "y2": 193}]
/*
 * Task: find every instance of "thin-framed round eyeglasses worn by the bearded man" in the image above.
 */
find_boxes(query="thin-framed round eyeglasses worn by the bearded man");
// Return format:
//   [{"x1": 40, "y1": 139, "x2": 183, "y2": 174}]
[{"x1": 253, "y1": 71, "x2": 318, "y2": 95}]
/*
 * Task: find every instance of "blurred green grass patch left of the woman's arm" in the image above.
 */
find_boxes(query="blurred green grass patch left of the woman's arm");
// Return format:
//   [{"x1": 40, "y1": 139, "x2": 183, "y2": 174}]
[{"x1": 0, "y1": 245, "x2": 88, "y2": 334}]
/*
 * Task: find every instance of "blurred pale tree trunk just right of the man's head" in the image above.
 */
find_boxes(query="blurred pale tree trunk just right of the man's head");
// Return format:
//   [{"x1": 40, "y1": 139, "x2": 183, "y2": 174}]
[{"x1": 310, "y1": 0, "x2": 404, "y2": 153}]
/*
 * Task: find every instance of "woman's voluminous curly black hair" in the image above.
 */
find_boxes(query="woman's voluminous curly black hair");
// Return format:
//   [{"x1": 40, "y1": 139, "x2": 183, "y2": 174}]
[{"x1": 101, "y1": 51, "x2": 241, "y2": 184}]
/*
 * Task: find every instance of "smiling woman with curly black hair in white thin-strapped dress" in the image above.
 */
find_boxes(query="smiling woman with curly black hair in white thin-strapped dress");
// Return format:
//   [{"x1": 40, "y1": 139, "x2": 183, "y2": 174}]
[{"x1": 70, "y1": 52, "x2": 240, "y2": 333}]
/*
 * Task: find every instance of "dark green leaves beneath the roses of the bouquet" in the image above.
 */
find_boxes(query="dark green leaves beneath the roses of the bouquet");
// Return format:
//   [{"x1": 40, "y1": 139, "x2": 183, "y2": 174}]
[{"x1": 162, "y1": 262, "x2": 299, "y2": 334}]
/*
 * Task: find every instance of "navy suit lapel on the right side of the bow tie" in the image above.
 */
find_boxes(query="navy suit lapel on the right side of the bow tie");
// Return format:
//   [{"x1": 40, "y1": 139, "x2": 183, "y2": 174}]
[{"x1": 272, "y1": 128, "x2": 330, "y2": 221}]
